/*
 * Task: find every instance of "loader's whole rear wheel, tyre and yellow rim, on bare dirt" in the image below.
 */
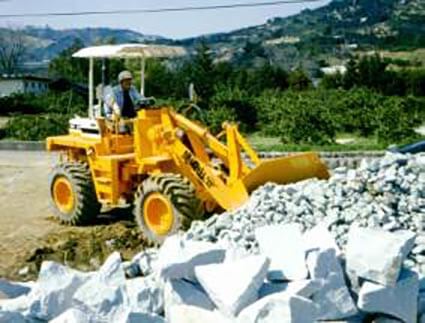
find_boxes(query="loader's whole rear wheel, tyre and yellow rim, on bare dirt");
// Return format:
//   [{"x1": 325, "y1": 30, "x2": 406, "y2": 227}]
[{"x1": 49, "y1": 162, "x2": 101, "y2": 225}]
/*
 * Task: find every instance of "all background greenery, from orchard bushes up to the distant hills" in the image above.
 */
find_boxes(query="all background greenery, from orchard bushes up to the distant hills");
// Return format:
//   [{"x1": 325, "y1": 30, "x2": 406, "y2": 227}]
[{"x1": 0, "y1": 0, "x2": 425, "y2": 148}]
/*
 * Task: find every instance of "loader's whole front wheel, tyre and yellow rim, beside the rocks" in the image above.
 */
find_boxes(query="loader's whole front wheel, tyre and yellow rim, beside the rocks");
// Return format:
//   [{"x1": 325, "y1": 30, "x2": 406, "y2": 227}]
[{"x1": 134, "y1": 174, "x2": 204, "y2": 245}]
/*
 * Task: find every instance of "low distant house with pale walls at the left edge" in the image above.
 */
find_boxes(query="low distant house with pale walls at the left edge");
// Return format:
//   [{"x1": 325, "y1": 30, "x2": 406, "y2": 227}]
[{"x1": 0, "y1": 75, "x2": 50, "y2": 97}]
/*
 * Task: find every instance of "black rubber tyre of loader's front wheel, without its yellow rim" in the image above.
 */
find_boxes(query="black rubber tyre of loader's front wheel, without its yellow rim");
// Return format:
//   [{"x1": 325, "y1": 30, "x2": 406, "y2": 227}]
[{"x1": 134, "y1": 173, "x2": 204, "y2": 245}]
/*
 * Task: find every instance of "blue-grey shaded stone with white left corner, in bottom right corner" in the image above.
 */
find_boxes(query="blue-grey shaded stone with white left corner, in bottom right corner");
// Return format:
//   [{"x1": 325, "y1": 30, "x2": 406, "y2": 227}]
[{"x1": 358, "y1": 269, "x2": 419, "y2": 323}]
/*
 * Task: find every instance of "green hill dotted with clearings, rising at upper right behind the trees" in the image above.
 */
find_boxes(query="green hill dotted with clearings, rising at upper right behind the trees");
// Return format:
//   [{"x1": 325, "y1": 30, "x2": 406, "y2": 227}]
[{"x1": 180, "y1": 0, "x2": 425, "y2": 71}]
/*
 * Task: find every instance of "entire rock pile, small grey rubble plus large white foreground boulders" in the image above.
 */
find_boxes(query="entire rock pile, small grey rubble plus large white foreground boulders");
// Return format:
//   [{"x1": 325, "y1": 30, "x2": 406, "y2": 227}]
[{"x1": 0, "y1": 154, "x2": 425, "y2": 323}]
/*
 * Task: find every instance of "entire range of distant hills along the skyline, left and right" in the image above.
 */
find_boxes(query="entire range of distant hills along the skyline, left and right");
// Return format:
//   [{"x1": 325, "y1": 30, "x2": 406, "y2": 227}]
[{"x1": 0, "y1": 0, "x2": 425, "y2": 76}]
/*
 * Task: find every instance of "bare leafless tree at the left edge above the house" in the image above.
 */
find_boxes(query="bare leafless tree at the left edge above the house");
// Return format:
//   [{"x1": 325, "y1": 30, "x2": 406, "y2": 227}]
[{"x1": 0, "y1": 29, "x2": 27, "y2": 74}]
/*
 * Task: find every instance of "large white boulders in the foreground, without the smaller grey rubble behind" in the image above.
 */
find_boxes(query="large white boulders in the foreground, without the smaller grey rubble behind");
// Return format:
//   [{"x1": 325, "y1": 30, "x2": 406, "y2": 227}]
[{"x1": 0, "y1": 224, "x2": 425, "y2": 323}]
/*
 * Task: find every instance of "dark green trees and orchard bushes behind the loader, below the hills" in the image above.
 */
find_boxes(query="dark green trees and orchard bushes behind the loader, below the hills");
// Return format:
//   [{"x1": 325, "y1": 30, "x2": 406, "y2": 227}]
[{"x1": 0, "y1": 44, "x2": 425, "y2": 147}]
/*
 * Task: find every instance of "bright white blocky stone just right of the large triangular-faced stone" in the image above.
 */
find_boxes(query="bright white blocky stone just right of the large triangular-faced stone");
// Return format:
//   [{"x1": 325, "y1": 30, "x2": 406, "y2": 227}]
[{"x1": 255, "y1": 224, "x2": 308, "y2": 280}]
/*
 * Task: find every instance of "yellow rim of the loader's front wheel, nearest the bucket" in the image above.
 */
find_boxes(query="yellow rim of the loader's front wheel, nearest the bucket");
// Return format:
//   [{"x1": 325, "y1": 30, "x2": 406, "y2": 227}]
[{"x1": 143, "y1": 193, "x2": 174, "y2": 236}]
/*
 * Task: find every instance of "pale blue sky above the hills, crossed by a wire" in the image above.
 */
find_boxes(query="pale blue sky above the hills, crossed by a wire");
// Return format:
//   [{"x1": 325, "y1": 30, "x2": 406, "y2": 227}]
[{"x1": 0, "y1": 0, "x2": 330, "y2": 39}]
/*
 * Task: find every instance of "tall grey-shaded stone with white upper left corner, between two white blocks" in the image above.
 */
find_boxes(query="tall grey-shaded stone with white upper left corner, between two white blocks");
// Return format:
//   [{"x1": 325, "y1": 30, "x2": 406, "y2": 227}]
[{"x1": 307, "y1": 249, "x2": 357, "y2": 320}]
